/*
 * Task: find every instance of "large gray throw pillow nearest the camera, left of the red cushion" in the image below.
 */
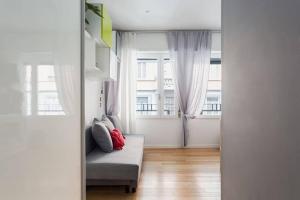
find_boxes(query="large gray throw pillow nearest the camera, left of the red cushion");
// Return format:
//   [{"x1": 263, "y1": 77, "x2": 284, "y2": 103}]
[{"x1": 92, "y1": 119, "x2": 113, "y2": 153}]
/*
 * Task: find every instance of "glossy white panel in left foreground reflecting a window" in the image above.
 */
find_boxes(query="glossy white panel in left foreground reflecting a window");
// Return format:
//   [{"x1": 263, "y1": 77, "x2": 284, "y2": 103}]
[{"x1": 0, "y1": 0, "x2": 81, "y2": 200}]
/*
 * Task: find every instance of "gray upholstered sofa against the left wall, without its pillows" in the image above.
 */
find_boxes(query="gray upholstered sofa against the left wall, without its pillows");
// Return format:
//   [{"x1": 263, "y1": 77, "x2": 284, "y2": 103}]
[{"x1": 86, "y1": 128, "x2": 144, "y2": 192}]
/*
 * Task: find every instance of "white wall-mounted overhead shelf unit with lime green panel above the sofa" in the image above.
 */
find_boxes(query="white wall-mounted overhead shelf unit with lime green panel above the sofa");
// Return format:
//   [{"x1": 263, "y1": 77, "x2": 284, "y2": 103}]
[{"x1": 85, "y1": 5, "x2": 117, "y2": 81}]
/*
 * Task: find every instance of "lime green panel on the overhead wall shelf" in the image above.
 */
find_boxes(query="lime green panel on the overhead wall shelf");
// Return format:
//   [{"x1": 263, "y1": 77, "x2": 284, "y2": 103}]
[{"x1": 101, "y1": 4, "x2": 112, "y2": 47}]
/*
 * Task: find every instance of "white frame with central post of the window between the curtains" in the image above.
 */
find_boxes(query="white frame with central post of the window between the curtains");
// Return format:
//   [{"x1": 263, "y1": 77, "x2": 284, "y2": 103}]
[{"x1": 136, "y1": 51, "x2": 179, "y2": 119}]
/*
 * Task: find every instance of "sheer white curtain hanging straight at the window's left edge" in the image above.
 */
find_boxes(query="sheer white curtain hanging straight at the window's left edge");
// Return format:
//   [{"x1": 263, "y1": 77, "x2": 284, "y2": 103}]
[{"x1": 120, "y1": 32, "x2": 137, "y2": 133}]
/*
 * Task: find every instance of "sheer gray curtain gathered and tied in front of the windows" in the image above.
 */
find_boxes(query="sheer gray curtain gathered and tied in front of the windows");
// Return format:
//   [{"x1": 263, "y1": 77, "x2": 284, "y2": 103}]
[{"x1": 168, "y1": 31, "x2": 211, "y2": 146}]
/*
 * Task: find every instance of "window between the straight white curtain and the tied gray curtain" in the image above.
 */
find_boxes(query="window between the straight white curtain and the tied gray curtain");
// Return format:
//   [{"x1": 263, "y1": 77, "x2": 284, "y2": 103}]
[{"x1": 136, "y1": 52, "x2": 178, "y2": 117}]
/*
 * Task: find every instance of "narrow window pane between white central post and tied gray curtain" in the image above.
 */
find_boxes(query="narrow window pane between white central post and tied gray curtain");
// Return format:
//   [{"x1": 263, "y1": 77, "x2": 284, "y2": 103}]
[{"x1": 163, "y1": 60, "x2": 176, "y2": 116}]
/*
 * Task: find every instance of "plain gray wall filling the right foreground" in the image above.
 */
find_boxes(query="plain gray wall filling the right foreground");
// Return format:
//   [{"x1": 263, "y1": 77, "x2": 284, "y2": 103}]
[{"x1": 221, "y1": 0, "x2": 300, "y2": 200}]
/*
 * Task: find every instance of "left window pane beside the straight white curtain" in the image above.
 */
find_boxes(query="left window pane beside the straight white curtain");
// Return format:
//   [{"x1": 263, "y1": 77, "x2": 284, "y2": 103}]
[{"x1": 136, "y1": 59, "x2": 159, "y2": 116}]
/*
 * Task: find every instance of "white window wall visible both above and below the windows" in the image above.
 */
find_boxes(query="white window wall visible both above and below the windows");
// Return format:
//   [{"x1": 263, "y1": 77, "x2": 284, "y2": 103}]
[{"x1": 137, "y1": 32, "x2": 221, "y2": 148}]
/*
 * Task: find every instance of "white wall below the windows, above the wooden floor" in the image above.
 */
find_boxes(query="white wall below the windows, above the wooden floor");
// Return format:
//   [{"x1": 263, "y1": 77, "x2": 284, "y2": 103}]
[{"x1": 136, "y1": 118, "x2": 220, "y2": 148}]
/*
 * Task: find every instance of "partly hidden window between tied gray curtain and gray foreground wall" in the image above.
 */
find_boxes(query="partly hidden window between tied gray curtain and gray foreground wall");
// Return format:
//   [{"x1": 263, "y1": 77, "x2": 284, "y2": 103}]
[{"x1": 202, "y1": 52, "x2": 222, "y2": 116}]
